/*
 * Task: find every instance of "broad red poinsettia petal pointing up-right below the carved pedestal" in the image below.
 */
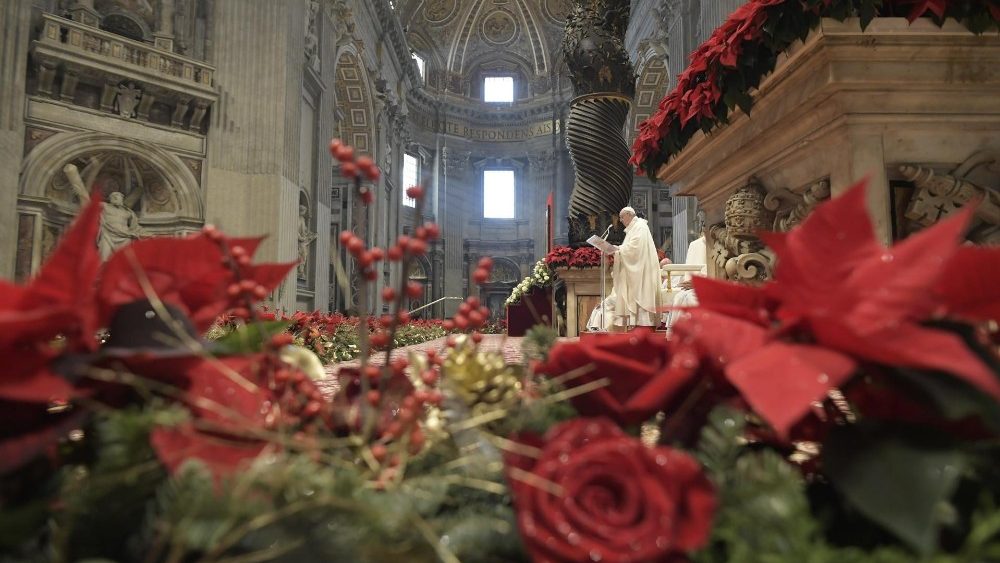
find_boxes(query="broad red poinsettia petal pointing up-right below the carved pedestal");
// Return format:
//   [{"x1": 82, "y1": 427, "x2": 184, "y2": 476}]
[{"x1": 831, "y1": 203, "x2": 972, "y2": 335}]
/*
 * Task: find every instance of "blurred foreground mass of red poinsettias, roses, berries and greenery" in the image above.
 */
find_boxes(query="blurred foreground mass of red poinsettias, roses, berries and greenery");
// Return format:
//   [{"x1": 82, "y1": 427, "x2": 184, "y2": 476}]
[{"x1": 0, "y1": 133, "x2": 1000, "y2": 563}]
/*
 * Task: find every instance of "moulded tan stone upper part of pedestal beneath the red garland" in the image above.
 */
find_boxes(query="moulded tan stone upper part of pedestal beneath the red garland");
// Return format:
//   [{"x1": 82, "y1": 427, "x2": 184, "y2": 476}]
[{"x1": 657, "y1": 18, "x2": 1000, "y2": 258}]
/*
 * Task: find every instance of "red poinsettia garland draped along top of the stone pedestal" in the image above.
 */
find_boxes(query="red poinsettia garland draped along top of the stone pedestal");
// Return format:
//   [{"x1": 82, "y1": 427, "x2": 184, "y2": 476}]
[{"x1": 630, "y1": 0, "x2": 1000, "y2": 179}]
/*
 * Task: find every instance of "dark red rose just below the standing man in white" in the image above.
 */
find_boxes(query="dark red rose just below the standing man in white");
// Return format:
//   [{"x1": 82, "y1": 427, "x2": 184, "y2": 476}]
[{"x1": 538, "y1": 330, "x2": 698, "y2": 425}]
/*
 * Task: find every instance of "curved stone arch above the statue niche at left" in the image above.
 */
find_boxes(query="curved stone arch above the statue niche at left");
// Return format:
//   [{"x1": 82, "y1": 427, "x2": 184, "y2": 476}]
[{"x1": 18, "y1": 132, "x2": 205, "y2": 226}]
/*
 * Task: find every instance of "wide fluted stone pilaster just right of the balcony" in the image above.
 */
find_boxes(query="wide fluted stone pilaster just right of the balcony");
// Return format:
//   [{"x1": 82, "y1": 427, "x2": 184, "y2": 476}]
[{"x1": 205, "y1": 0, "x2": 303, "y2": 310}]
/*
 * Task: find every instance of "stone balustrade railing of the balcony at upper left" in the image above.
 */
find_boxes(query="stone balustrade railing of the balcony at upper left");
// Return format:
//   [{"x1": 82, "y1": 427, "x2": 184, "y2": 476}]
[{"x1": 39, "y1": 14, "x2": 215, "y2": 88}]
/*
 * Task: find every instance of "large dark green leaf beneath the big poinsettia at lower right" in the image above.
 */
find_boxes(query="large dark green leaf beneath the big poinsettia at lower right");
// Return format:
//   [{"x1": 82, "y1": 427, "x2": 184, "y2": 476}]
[{"x1": 823, "y1": 420, "x2": 966, "y2": 555}]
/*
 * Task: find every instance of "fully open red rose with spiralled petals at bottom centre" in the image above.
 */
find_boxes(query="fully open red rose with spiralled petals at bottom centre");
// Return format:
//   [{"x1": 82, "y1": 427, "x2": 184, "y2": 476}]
[{"x1": 508, "y1": 418, "x2": 716, "y2": 563}]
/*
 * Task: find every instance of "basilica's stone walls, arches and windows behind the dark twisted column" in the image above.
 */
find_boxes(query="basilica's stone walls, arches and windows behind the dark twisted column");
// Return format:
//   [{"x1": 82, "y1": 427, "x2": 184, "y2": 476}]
[{"x1": 0, "y1": 0, "x2": 740, "y2": 318}]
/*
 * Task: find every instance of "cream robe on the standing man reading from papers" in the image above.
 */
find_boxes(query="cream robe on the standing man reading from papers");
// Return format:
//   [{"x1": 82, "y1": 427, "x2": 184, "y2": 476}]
[{"x1": 611, "y1": 217, "x2": 660, "y2": 326}]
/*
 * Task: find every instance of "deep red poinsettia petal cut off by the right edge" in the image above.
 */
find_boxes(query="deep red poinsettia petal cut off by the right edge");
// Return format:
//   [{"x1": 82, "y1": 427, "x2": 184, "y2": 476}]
[{"x1": 931, "y1": 246, "x2": 1000, "y2": 321}]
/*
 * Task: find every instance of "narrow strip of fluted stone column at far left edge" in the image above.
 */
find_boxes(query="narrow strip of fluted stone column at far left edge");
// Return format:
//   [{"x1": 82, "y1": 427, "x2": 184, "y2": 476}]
[{"x1": 0, "y1": 0, "x2": 31, "y2": 279}]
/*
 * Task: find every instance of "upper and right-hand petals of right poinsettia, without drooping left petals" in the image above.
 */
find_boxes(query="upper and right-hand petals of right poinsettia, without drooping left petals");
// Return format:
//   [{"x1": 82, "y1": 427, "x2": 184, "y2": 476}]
[{"x1": 764, "y1": 181, "x2": 1000, "y2": 398}]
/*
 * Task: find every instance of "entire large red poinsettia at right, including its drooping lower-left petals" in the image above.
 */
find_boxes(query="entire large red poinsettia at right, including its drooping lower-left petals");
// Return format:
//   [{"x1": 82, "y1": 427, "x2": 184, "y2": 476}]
[{"x1": 674, "y1": 178, "x2": 1000, "y2": 436}]
